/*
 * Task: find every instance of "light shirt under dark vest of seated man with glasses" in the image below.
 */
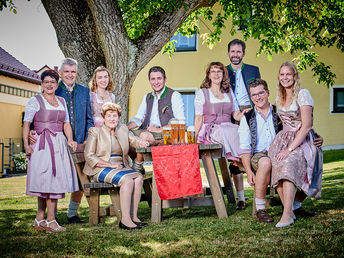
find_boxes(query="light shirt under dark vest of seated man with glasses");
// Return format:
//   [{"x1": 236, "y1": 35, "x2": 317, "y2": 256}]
[{"x1": 238, "y1": 104, "x2": 276, "y2": 154}]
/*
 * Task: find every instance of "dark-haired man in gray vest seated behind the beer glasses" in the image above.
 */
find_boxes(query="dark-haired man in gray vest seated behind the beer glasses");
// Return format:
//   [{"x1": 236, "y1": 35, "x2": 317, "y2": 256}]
[{"x1": 128, "y1": 66, "x2": 185, "y2": 170}]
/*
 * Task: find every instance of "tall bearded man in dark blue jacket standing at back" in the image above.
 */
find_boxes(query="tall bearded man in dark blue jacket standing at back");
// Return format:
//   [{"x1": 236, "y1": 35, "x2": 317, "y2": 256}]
[{"x1": 227, "y1": 39, "x2": 260, "y2": 210}]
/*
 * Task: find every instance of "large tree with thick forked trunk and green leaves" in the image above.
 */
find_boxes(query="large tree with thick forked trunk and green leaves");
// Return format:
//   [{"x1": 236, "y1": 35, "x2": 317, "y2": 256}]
[{"x1": 0, "y1": 0, "x2": 344, "y2": 119}]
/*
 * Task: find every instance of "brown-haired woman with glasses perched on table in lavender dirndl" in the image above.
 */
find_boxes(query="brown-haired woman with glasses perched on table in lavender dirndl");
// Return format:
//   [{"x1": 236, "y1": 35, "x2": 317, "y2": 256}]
[{"x1": 195, "y1": 62, "x2": 242, "y2": 164}]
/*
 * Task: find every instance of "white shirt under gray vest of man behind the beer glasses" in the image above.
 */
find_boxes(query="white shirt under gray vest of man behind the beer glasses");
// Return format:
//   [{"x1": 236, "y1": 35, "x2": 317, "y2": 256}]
[{"x1": 129, "y1": 86, "x2": 185, "y2": 127}]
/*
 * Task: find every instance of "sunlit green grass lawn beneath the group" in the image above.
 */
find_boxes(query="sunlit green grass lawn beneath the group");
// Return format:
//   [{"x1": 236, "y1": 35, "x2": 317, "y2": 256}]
[{"x1": 0, "y1": 151, "x2": 344, "y2": 257}]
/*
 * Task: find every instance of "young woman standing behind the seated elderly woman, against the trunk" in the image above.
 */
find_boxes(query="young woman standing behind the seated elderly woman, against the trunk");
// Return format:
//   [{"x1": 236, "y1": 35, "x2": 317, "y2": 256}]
[{"x1": 88, "y1": 66, "x2": 116, "y2": 126}]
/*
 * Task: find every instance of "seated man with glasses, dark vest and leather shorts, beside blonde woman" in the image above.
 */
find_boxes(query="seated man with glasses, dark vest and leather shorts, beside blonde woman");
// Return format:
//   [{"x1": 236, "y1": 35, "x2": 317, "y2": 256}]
[{"x1": 239, "y1": 79, "x2": 323, "y2": 223}]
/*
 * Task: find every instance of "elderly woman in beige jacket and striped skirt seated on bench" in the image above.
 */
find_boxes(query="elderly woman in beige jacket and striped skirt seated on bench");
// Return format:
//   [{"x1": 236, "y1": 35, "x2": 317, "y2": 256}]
[{"x1": 84, "y1": 103, "x2": 149, "y2": 230}]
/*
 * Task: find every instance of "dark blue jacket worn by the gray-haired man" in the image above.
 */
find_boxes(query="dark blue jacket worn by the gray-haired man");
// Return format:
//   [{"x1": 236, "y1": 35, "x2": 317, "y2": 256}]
[{"x1": 55, "y1": 83, "x2": 94, "y2": 143}]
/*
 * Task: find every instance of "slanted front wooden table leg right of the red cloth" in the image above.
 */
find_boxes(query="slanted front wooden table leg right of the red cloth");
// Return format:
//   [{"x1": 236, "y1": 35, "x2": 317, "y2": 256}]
[{"x1": 200, "y1": 150, "x2": 228, "y2": 219}]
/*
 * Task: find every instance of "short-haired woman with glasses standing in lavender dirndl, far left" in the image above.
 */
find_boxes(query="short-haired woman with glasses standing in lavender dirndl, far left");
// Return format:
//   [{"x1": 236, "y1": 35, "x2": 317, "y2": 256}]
[{"x1": 23, "y1": 70, "x2": 79, "y2": 232}]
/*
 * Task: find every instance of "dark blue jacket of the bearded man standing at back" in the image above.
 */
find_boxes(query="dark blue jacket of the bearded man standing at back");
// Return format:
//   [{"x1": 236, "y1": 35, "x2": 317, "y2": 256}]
[{"x1": 226, "y1": 64, "x2": 260, "y2": 106}]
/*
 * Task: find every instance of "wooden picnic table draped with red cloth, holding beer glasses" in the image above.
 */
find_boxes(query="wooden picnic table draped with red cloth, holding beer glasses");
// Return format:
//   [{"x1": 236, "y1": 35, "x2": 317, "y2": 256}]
[{"x1": 136, "y1": 144, "x2": 235, "y2": 223}]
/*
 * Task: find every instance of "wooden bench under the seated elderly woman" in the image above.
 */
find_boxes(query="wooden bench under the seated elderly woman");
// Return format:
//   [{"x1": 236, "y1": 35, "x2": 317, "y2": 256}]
[{"x1": 71, "y1": 144, "x2": 152, "y2": 225}]
